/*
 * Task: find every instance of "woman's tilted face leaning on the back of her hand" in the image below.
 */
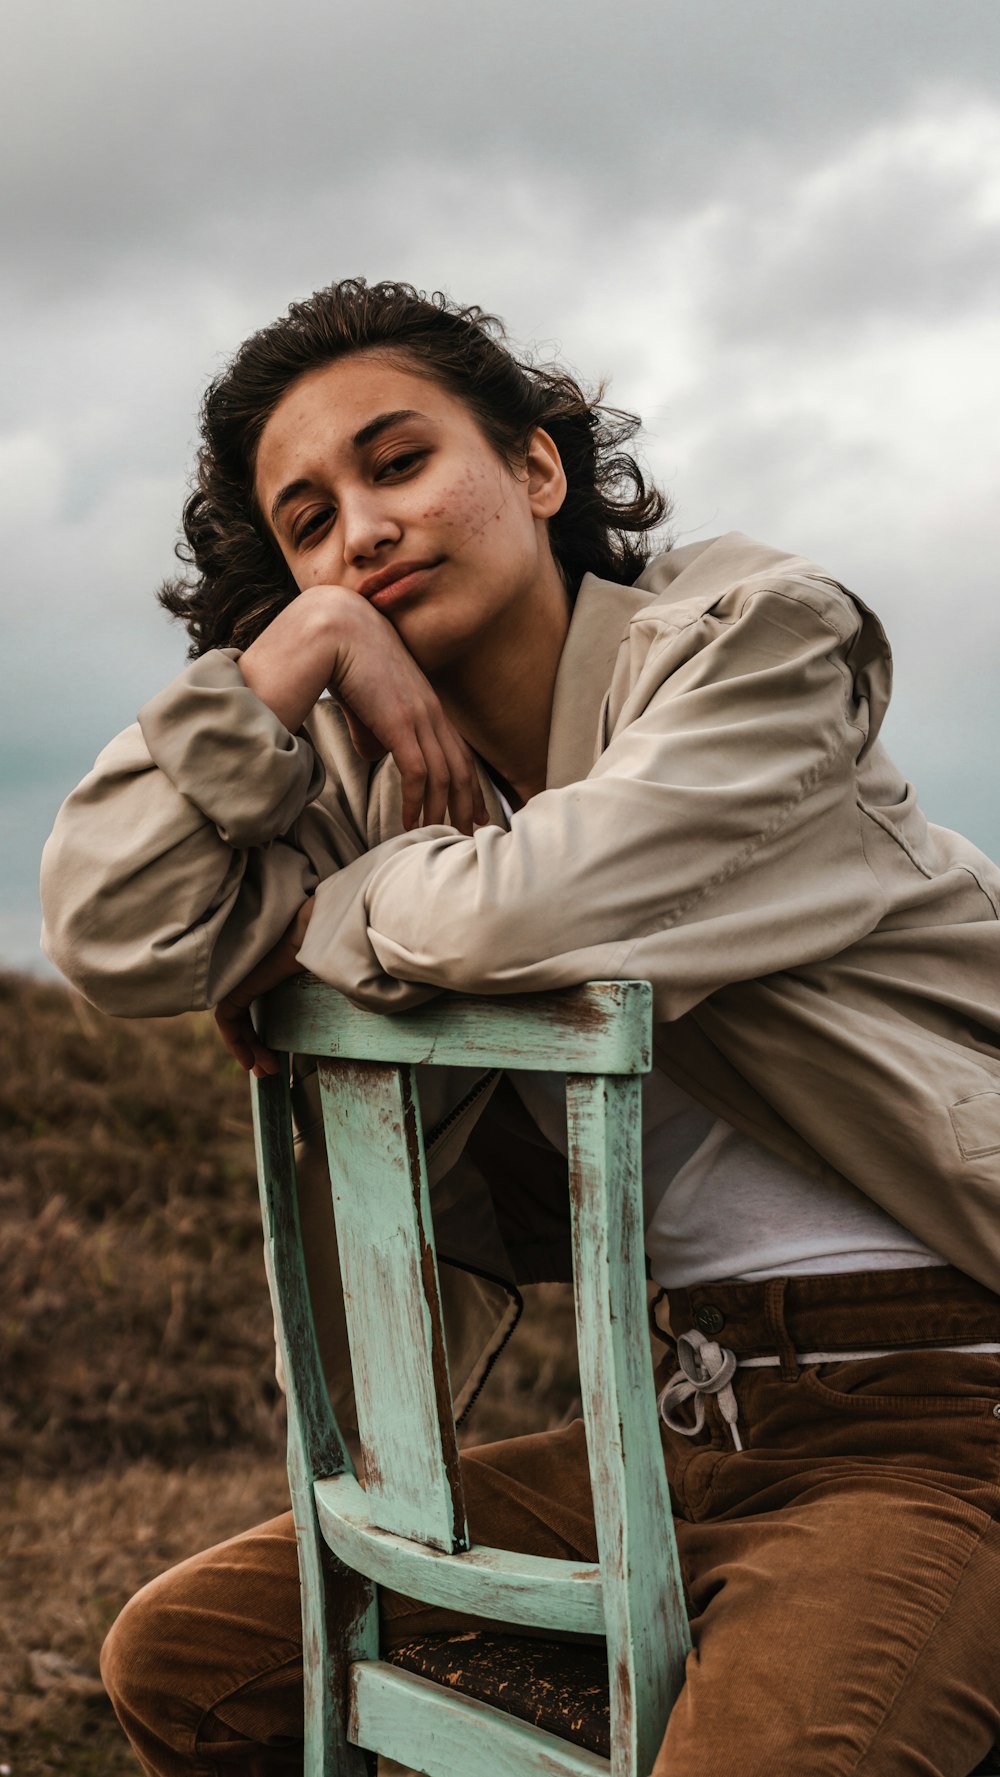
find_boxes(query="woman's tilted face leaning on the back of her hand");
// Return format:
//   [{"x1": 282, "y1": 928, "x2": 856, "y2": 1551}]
[{"x1": 256, "y1": 352, "x2": 565, "y2": 672}]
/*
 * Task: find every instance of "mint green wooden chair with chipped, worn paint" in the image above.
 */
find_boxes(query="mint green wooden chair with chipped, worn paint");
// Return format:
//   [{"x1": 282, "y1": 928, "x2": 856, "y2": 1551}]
[{"x1": 254, "y1": 977, "x2": 689, "y2": 1777}]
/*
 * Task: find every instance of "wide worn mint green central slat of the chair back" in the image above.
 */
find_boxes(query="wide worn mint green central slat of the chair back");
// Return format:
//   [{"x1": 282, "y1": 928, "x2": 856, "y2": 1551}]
[{"x1": 320, "y1": 1061, "x2": 469, "y2": 1553}]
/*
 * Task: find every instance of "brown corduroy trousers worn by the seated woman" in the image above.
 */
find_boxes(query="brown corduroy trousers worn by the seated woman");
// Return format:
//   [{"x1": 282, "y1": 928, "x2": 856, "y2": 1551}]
[{"x1": 103, "y1": 1267, "x2": 1000, "y2": 1777}]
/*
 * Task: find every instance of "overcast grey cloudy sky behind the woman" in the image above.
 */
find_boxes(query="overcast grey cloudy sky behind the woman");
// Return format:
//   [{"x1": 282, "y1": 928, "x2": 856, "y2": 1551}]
[{"x1": 0, "y1": 0, "x2": 1000, "y2": 968}]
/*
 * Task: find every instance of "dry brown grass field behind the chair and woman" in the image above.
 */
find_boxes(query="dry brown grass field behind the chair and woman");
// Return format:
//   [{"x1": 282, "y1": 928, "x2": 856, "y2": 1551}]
[{"x1": 0, "y1": 976, "x2": 575, "y2": 1777}]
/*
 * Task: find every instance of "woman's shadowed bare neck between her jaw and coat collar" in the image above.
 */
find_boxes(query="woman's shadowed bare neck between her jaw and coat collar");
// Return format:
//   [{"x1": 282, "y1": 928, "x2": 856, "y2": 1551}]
[{"x1": 435, "y1": 563, "x2": 570, "y2": 801}]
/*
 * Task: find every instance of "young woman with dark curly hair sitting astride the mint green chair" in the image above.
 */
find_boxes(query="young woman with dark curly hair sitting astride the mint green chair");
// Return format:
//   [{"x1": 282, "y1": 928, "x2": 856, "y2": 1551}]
[{"x1": 44, "y1": 281, "x2": 1000, "y2": 1777}]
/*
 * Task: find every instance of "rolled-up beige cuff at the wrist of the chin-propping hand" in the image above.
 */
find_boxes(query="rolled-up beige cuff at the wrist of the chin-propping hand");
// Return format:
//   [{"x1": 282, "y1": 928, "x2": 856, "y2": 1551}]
[{"x1": 139, "y1": 649, "x2": 325, "y2": 849}]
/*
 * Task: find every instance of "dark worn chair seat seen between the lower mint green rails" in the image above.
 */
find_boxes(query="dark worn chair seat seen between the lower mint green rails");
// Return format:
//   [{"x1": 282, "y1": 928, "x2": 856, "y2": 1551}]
[{"x1": 384, "y1": 1630, "x2": 611, "y2": 1757}]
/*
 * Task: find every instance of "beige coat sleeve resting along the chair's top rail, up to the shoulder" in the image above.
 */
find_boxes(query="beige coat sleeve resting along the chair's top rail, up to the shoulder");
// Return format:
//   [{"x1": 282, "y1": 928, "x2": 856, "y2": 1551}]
[{"x1": 300, "y1": 586, "x2": 883, "y2": 1018}]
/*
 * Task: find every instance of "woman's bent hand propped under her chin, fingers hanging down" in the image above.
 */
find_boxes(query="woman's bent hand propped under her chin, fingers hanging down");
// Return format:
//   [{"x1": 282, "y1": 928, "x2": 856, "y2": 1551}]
[{"x1": 240, "y1": 586, "x2": 488, "y2": 833}]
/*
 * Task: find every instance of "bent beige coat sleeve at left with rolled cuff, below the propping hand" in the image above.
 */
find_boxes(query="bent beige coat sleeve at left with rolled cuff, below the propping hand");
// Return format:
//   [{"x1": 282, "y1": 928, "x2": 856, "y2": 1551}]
[{"x1": 41, "y1": 652, "x2": 364, "y2": 1016}]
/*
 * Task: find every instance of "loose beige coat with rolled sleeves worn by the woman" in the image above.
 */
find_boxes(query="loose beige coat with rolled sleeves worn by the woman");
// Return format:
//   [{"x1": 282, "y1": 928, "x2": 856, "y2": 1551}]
[{"x1": 43, "y1": 535, "x2": 1000, "y2": 1378}]
